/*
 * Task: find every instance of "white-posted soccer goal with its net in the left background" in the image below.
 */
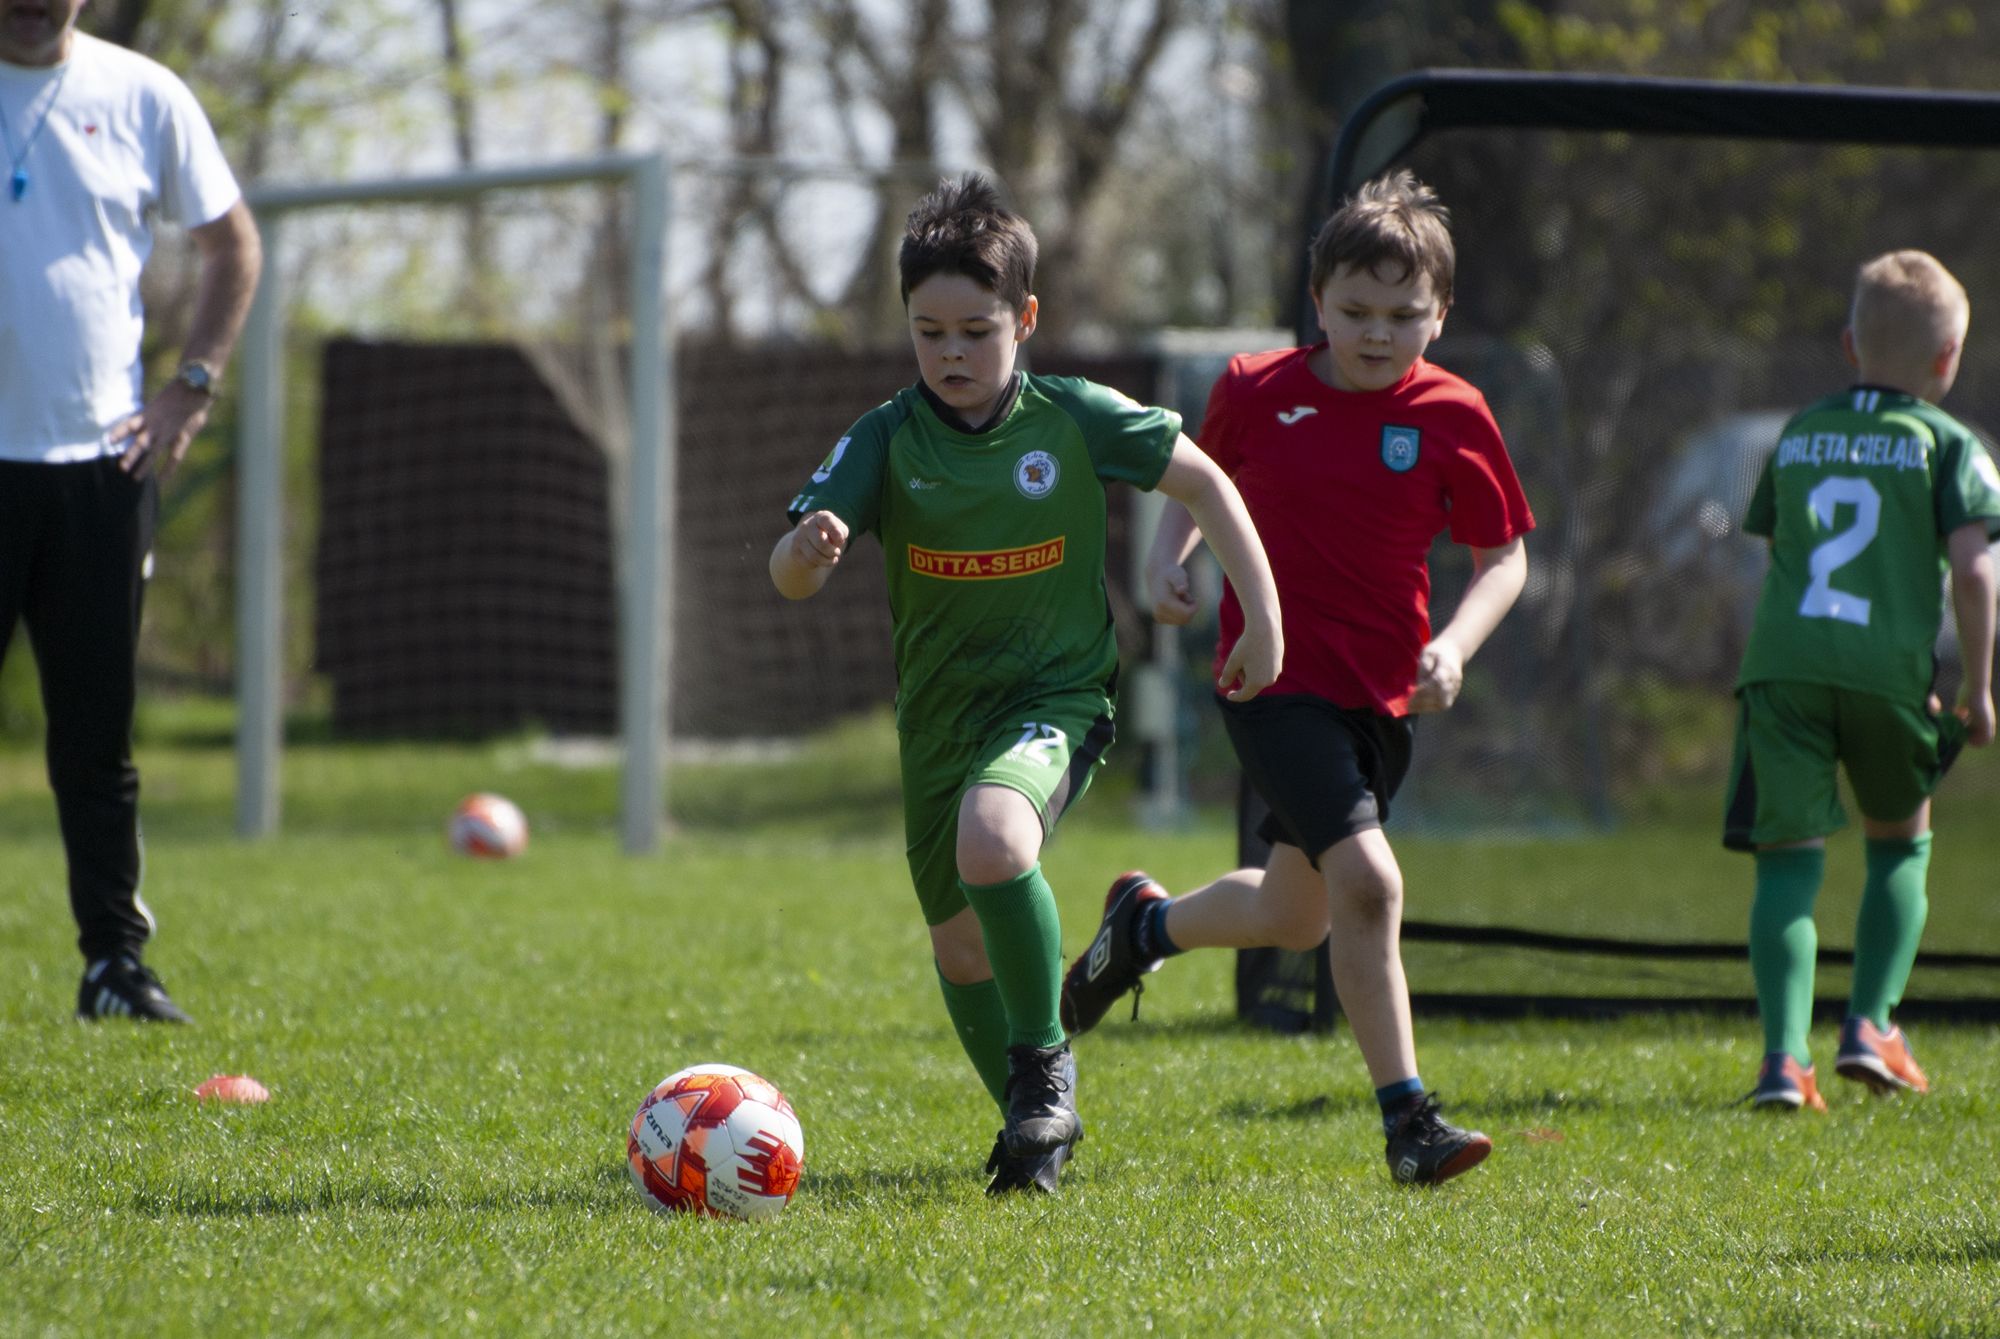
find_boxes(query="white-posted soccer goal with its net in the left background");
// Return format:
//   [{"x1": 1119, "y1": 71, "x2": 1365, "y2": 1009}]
[{"x1": 219, "y1": 160, "x2": 1156, "y2": 849}]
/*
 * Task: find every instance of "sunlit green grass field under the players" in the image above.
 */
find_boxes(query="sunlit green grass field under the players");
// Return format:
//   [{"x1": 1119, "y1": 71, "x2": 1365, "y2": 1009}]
[{"x1": 0, "y1": 715, "x2": 2000, "y2": 1337}]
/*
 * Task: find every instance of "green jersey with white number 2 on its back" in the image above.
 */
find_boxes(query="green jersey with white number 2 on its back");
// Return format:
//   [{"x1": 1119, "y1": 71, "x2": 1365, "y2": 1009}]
[{"x1": 1736, "y1": 386, "x2": 2000, "y2": 701}]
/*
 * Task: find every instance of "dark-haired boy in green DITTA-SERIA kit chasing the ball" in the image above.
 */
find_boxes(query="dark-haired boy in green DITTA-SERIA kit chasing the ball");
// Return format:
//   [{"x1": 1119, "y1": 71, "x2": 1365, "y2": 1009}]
[{"x1": 770, "y1": 174, "x2": 1284, "y2": 1193}]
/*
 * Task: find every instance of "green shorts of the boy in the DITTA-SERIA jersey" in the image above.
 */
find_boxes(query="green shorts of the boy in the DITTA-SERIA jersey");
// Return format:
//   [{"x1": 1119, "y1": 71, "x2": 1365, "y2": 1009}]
[{"x1": 898, "y1": 693, "x2": 1114, "y2": 925}]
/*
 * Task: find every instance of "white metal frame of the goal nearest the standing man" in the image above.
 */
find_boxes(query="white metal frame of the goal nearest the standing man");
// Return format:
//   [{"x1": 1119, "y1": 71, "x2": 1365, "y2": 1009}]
[{"x1": 236, "y1": 154, "x2": 676, "y2": 853}]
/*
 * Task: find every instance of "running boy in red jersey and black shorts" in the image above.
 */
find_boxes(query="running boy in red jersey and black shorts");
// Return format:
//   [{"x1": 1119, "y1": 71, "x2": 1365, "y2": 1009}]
[{"x1": 1062, "y1": 172, "x2": 1534, "y2": 1181}]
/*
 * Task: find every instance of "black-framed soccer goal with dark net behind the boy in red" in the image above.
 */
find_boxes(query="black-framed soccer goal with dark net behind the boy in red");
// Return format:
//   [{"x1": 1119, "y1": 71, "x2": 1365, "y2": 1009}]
[{"x1": 1240, "y1": 70, "x2": 2000, "y2": 1025}]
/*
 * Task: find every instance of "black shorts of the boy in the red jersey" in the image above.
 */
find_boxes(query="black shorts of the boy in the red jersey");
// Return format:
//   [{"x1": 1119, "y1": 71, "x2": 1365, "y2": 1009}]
[{"x1": 1216, "y1": 693, "x2": 1416, "y2": 867}]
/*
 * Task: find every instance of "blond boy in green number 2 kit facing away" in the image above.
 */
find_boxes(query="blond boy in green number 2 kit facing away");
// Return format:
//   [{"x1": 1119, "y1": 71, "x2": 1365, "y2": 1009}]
[{"x1": 1722, "y1": 252, "x2": 2000, "y2": 1111}]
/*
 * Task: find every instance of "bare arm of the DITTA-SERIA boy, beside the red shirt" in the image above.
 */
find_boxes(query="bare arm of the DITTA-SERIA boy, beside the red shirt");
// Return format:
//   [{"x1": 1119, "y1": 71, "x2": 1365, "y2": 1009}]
[{"x1": 1148, "y1": 434, "x2": 1284, "y2": 701}]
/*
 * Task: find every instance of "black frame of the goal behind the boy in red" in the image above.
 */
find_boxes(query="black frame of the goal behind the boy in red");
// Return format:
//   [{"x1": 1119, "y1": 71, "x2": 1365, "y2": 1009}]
[{"x1": 1236, "y1": 70, "x2": 2000, "y2": 1031}]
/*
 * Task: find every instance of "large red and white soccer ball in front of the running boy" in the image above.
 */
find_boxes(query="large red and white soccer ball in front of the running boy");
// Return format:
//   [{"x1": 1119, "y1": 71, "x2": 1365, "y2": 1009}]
[{"x1": 626, "y1": 1065, "x2": 806, "y2": 1219}]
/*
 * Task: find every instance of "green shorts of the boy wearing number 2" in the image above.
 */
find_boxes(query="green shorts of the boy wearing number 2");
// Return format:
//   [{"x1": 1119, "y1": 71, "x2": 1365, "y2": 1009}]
[{"x1": 1722, "y1": 679, "x2": 1966, "y2": 851}]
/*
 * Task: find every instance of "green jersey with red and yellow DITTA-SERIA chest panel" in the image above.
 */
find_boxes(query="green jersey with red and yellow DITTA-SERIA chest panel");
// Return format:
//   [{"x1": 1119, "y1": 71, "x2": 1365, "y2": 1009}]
[{"x1": 788, "y1": 374, "x2": 1180, "y2": 741}]
